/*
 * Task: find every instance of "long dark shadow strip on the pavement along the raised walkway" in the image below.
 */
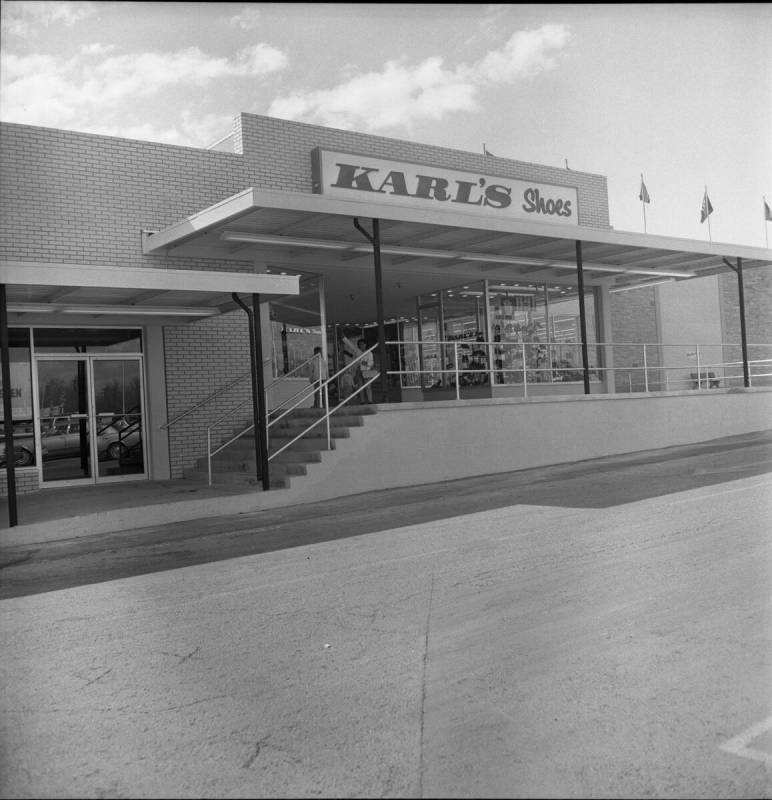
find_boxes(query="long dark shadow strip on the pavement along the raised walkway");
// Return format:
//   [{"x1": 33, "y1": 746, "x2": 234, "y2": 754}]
[{"x1": 0, "y1": 431, "x2": 772, "y2": 599}]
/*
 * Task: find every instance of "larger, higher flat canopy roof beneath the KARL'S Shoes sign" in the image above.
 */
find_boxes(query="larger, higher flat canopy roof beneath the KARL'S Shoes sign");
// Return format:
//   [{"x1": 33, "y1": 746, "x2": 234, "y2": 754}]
[{"x1": 143, "y1": 189, "x2": 772, "y2": 324}]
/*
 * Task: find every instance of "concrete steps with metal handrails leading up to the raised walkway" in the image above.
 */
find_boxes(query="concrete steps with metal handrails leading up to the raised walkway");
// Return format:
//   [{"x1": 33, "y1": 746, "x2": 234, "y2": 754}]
[{"x1": 185, "y1": 405, "x2": 377, "y2": 489}]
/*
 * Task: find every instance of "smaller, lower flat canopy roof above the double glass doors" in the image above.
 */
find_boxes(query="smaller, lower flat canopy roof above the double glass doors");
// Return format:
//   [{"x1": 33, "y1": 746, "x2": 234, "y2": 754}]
[{"x1": 0, "y1": 261, "x2": 300, "y2": 327}]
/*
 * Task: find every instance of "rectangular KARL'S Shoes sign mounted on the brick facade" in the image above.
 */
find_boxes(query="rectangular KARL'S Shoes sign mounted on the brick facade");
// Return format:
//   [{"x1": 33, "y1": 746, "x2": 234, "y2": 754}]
[{"x1": 311, "y1": 148, "x2": 578, "y2": 225}]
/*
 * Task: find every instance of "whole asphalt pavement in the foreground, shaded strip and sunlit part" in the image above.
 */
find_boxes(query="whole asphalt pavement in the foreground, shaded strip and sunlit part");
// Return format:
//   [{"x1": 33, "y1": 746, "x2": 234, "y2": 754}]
[{"x1": 0, "y1": 437, "x2": 772, "y2": 798}]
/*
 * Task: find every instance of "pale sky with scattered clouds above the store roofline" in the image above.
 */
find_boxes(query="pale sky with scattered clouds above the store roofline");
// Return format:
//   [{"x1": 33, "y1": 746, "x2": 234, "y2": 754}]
[{"x1": 0, "y1": 0, "x2": 772, "y2": 247}]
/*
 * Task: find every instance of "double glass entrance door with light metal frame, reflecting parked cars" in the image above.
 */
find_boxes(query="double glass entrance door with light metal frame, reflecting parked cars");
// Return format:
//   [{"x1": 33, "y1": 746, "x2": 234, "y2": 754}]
[{"x1": 36, "y1": 356, "x2": 145, "y2": 484}]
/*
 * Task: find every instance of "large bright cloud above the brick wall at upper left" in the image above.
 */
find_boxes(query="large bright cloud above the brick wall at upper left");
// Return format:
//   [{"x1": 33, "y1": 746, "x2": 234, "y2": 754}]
[{"x1": 0, "y1": 43, "x2": 288, "y2": 141}]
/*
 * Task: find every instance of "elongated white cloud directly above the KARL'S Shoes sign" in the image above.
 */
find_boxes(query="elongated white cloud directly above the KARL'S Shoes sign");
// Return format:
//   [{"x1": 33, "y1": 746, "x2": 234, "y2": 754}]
[{"x1": 268, "y1": 25, "x2": 571, "y2": 131}]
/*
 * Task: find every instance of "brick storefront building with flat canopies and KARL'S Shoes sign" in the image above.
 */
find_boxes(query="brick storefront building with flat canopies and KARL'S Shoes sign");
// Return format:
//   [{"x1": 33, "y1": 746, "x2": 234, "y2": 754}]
[{"x1": 0, "y1": 114, "x2": 772, "y2": 512}]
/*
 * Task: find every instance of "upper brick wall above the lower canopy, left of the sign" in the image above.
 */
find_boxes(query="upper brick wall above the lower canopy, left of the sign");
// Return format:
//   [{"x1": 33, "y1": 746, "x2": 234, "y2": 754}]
[{"x1": 0, "y1": 123, "x2": 249, "y2": 271}]
